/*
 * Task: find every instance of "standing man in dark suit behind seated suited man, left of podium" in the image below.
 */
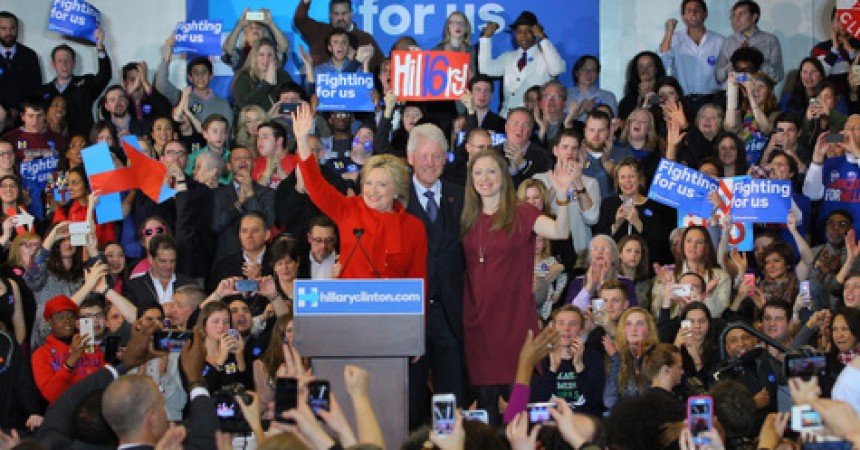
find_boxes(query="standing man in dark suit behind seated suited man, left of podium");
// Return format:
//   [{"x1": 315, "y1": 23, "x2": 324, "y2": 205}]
[{"x1": 212, "y1": 147, "x2": 275, "y2": 261}]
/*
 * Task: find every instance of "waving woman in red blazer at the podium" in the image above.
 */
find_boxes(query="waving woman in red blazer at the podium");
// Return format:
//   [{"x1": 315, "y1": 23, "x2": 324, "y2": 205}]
[{"x1": 292, "y1": 105, "x2": 427, "y2": 278}]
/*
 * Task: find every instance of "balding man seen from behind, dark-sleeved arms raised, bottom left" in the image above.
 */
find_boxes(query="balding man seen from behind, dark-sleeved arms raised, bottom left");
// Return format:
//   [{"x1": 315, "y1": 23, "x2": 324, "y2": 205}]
[{"x1": 36, "y1": 322, "x2": 218, "y2": 450}]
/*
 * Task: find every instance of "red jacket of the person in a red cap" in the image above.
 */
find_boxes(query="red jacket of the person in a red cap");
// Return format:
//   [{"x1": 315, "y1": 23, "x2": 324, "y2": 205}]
[{"x1": 32, "y1": 333, "x2": 105, "y2": 403}]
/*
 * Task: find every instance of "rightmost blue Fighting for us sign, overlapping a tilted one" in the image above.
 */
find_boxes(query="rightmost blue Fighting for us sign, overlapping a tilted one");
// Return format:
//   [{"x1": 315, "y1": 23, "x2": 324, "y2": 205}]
[{"x1": 732, "y1": 178, "x2": 791, "y2": 223}]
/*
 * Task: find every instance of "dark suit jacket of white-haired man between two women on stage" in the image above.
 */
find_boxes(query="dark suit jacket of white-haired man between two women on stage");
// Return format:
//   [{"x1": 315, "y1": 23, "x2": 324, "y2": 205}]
[{"x1": 406, "y1": 180, "x2": 465, "y2": 341}]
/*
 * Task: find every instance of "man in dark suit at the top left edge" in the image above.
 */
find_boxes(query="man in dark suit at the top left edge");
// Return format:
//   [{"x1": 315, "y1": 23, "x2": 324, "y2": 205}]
[{"x1": 0, "y1": 11, "x2": 42, "y2": 118}]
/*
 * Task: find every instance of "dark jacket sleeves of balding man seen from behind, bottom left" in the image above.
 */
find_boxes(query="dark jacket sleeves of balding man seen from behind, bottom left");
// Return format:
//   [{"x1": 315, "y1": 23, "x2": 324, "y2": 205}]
[{"x1": 36, "y1": 368, "x2": 218, "y2": 450}]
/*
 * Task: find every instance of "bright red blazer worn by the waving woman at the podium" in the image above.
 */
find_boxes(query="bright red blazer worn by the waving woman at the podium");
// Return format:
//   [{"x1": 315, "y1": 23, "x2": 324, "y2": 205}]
[{"x1": 299, "y1": 156, "x2": 427, "y2": 285}]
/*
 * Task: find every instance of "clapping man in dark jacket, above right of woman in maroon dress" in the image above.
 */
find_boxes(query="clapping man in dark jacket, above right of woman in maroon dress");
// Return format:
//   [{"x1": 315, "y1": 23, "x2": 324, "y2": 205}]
[{"x1": 495, "y1": 107, "x2": 552, "y2": 187}]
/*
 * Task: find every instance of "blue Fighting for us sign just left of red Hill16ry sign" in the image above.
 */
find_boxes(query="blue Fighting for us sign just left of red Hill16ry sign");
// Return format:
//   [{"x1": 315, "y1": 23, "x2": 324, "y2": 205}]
[{"x1": 316, "y1": 72, "x2": 376, "y2": 111}]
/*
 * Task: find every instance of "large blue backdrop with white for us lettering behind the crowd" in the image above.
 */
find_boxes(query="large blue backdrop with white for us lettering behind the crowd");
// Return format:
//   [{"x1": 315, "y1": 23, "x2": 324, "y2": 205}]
[{"x1": 187, "y1": 0, "x2": 600, "y2": 103}]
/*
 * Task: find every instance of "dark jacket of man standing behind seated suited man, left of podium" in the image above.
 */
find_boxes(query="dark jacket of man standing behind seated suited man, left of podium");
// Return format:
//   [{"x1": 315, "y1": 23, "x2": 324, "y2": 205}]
[{"x1": 212, "y1": 183, "x2": 275, "y2": 261}]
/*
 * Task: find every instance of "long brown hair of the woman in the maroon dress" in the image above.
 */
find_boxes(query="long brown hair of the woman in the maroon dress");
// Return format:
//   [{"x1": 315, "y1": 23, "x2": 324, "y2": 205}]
[{"x1": 460, "y1": 149, "x2": 519, "y2": 236}]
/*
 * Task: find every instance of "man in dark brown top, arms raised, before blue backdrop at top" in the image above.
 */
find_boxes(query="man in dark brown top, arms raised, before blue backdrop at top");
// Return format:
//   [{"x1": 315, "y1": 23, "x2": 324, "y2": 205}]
[{"x1": 293, "y1": 0, "x2": 384, "y2": 72}]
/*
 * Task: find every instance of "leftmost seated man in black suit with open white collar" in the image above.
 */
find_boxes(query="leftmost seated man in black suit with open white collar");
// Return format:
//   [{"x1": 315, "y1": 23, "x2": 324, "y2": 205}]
[{"x1": 124, "y1": 234, "x2": 195, "y2": 311}]
